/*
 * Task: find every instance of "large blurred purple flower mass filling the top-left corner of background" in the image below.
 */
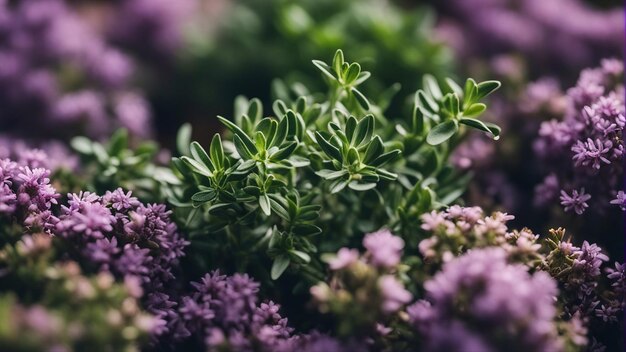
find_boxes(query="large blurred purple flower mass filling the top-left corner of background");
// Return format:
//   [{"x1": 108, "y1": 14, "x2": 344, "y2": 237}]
[{"x1": 0, "y1": 0, "x2": 150, "y2": 138}]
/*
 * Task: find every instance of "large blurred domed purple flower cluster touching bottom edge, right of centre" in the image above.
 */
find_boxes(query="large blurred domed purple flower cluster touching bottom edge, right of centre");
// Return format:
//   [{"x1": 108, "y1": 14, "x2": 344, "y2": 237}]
[{"x1": 407, "y1": 248, "x2": 563, "y2": 351}]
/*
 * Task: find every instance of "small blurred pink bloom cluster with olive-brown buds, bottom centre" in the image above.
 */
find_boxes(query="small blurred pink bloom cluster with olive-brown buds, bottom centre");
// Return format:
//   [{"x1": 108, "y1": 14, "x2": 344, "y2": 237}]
[{"x1": 310, "y1": 229, "x2": 413, "y2": 340}]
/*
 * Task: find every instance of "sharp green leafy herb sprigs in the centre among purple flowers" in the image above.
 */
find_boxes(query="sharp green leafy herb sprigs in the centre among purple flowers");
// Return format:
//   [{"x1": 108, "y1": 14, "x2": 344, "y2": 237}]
[{"x1": 170, "y1": 50, "x2": 499, "y2": 282}]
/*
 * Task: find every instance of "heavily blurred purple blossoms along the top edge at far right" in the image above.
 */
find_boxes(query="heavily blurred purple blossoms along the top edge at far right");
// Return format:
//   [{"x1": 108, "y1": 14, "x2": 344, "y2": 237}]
[{"x1": 439, "y1": 0, "x2": 624, "y2": 70}]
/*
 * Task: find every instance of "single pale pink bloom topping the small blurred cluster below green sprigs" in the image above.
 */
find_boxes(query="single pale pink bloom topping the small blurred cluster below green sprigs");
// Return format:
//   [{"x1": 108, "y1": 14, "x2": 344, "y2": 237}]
[{"x1": 363, "y1": 230, "x2": 404, "y2": 268}]
